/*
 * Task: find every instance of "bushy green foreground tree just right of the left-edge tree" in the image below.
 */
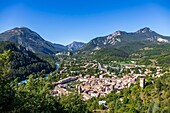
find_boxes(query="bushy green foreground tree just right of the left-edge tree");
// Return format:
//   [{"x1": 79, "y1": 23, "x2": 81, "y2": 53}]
[{"x1": 16, "y1": 75, "x2": 60, "y2": 113}]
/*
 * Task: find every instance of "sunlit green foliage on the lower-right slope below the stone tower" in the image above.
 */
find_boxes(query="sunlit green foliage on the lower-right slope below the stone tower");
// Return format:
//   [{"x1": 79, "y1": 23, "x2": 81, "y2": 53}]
[{"x1": 87, "y1": 74, "x2": 170, "y2": 113}]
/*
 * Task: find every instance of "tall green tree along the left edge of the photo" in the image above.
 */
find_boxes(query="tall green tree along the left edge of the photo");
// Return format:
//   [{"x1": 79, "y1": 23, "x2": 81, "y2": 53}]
[{"x1": 0, "y1": 51, "x2": 15, "y2": 112}]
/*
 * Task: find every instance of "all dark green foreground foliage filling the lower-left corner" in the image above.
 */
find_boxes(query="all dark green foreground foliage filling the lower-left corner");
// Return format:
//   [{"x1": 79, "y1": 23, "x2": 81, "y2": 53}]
[{"x1": 0, "y1": 51, "x2": 86, "y2": 113}]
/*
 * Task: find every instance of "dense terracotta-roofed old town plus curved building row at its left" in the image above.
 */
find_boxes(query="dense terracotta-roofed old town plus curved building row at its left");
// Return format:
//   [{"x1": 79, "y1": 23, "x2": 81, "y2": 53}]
[{"x1": 51, "y1": 75, "x2": 144, "y2": 100}]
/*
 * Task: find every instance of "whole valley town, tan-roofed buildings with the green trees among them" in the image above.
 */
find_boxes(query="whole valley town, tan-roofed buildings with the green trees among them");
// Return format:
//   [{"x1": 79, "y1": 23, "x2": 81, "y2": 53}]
[{"x1": 51, "y1": 58, "x2": 169, "y2": 101}]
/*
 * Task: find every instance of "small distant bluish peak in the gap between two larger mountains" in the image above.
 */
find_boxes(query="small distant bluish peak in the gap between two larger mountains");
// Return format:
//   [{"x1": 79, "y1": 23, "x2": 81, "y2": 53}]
[{"x1": 66, "y1": 41, "x2": 85, "y2": 51}]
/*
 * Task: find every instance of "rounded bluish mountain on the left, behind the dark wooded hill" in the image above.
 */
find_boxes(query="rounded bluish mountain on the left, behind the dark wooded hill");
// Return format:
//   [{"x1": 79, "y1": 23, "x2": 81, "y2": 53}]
[{"x1": 0, "y1": 27, "x2": 65, "y2": 54}]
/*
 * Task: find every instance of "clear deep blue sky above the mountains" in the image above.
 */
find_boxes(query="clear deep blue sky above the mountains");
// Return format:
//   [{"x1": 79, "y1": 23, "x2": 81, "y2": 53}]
[{"x1": 0, "y1": 0, "x2": 170, "y2": 45}]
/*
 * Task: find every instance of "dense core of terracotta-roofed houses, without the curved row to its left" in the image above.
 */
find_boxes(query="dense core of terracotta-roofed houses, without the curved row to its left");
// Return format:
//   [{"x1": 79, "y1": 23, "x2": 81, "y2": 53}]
[{"x1": 76, "y1": 75, "x2": 137, "y2": 100}]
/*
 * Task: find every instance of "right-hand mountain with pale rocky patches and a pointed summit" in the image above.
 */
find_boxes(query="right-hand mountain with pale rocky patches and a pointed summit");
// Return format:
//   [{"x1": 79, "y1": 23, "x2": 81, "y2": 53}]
[{"x1": 81, "y1": 27, "x2": 170, "y2": 51}]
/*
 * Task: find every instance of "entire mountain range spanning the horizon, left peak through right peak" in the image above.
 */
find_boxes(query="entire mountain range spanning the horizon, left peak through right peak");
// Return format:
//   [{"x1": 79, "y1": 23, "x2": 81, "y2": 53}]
[{"x1": 0, "y1": 27, "x2": 170, "y2": 54}]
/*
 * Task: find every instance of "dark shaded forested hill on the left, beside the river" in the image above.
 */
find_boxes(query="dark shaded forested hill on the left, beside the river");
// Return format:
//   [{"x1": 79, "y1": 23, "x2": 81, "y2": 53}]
[{"x1": 0, "y1": 42, "x2": 53, "y2": 80}]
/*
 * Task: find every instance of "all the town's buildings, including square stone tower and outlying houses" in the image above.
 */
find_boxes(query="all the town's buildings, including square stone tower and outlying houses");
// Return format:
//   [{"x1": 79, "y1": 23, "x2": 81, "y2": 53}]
[{"x1": 51, "y1": 61, "x2": 166, "y2": 100}]
